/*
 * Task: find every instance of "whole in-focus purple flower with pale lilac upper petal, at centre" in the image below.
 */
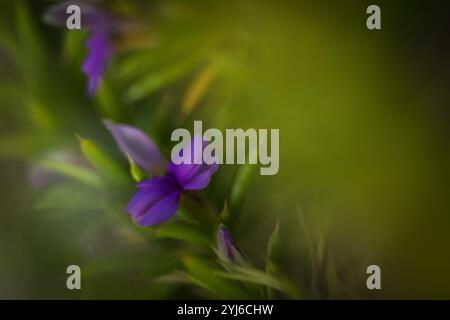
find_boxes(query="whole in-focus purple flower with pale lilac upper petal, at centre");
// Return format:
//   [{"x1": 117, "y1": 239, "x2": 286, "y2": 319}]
[{"x1": 106, "y1": 121, "x2": 219, "y2": 226}]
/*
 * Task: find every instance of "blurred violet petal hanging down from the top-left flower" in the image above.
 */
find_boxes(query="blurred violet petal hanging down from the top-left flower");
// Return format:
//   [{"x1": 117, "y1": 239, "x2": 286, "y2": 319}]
[{"x1": 83, "y1": 27, "x2": 114, "y2": 96}]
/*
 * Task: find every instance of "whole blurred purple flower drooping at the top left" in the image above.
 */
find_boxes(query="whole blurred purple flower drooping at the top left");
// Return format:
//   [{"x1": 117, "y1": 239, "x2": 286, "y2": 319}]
[{"x1": 43, "y1": 0, "x2": 114, "y2": 96}]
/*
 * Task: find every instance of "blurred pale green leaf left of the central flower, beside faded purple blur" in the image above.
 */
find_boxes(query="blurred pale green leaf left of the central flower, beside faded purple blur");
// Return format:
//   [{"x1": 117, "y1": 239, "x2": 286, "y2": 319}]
[{"x1": 40, "y1": 160, "x2": 102, "y2": 187}]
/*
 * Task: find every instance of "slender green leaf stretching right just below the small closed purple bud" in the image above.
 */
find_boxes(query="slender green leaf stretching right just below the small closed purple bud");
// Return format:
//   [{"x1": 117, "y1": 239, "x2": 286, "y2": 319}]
[{"x1": 216, "y1": 266, "x2": 302, "y2": 299}]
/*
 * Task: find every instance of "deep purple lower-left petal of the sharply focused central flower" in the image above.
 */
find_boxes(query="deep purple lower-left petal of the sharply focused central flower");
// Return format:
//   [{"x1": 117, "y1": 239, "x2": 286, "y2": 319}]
[{"x1": 128, "y1": 175, "x2": 183, "y2": 226}]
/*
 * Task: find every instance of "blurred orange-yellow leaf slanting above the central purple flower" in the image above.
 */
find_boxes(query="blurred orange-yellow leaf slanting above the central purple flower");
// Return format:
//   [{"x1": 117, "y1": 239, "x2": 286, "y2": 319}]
[{"x1": 181, "y1": 64, "x2": 217, "y2": 115}]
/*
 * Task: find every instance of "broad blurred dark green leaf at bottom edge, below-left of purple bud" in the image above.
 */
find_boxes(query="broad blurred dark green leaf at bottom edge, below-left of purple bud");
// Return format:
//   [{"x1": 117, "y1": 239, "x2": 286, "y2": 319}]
[{"x1": 183, "y1": 257, "x2": 252, "y2": 299}]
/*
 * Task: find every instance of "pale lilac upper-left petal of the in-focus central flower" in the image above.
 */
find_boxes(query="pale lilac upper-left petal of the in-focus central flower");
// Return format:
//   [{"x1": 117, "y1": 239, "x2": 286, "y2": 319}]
[{"x1": 105, "y1": 120, "x2": 165, "y2": 174}]
